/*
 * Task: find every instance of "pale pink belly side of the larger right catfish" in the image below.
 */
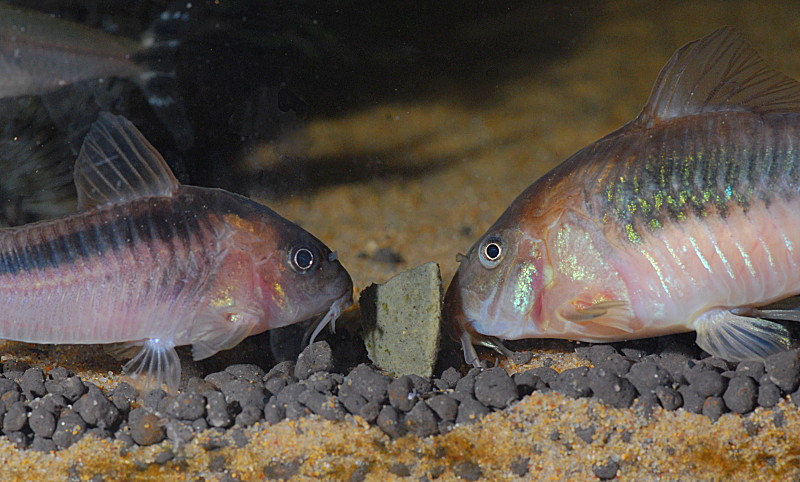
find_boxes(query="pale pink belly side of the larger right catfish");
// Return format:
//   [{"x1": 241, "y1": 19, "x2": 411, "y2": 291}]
[{"x1": 621, "y1": 196, "x2": 800, "y2": 336}]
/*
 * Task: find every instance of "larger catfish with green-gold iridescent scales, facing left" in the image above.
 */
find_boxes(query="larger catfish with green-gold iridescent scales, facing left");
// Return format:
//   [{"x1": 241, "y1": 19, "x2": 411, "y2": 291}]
[{"x1": 445, "y1": 27, "x2": 800, "y2": 363}]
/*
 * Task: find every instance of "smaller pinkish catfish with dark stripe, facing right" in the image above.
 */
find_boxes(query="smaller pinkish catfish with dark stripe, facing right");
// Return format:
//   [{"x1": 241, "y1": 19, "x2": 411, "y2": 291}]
[{"x1": 0, "y1": 113, "x2": 353, "y2": 391}]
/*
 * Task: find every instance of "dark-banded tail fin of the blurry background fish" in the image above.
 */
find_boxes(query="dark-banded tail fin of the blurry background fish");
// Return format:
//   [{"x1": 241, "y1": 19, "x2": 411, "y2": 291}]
[{"x1": 134, "y1": 1, "x2": 194, "y2": 150}]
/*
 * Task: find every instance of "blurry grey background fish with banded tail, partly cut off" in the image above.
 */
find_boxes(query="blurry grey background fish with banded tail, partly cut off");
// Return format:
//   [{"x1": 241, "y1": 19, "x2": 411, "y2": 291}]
[{"x1": 0, "y1": 2, "x2": 194, "y2": 149}]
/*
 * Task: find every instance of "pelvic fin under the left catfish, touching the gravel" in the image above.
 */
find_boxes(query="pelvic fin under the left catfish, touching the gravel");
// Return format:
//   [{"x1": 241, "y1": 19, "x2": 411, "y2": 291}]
[{"x1": 120, "y1": 338, "x2": 181, "y2": 396}]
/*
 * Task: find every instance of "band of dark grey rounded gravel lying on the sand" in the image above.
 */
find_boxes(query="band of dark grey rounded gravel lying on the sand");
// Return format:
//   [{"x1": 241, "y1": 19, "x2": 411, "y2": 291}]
[{"x1": 0, "y1": 341, "x2": 800, "y2": 452}]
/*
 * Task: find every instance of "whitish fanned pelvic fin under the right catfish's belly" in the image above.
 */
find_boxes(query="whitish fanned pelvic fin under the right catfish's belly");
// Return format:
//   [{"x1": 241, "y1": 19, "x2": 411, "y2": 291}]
[{"x1": 695, "y1": 308, "x2": 791, "y2": 361}]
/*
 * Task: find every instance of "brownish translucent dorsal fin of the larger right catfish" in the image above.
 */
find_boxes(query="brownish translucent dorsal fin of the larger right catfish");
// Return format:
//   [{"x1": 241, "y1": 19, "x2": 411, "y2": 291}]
[{"x1": 636, "y1": 27, "x2": 800, "y2": 126}]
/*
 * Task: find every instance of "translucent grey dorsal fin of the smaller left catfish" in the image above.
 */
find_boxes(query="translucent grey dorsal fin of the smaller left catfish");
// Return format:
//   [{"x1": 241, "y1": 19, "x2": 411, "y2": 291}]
[{"x1": 75, "y1": 112, "x2": 180, "y2": 209}]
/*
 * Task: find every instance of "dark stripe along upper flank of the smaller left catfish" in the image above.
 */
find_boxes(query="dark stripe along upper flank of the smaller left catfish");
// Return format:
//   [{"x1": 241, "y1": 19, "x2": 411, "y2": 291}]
[{"x1": 0, "y1": 198, "x2": 210, "y2": 275}]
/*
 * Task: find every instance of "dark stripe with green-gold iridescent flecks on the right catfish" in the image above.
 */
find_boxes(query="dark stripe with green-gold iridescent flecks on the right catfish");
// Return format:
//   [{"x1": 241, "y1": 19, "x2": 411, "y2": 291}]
[{"x1": 588, "y1": 116, "x2": 800, "y2": 241}]
